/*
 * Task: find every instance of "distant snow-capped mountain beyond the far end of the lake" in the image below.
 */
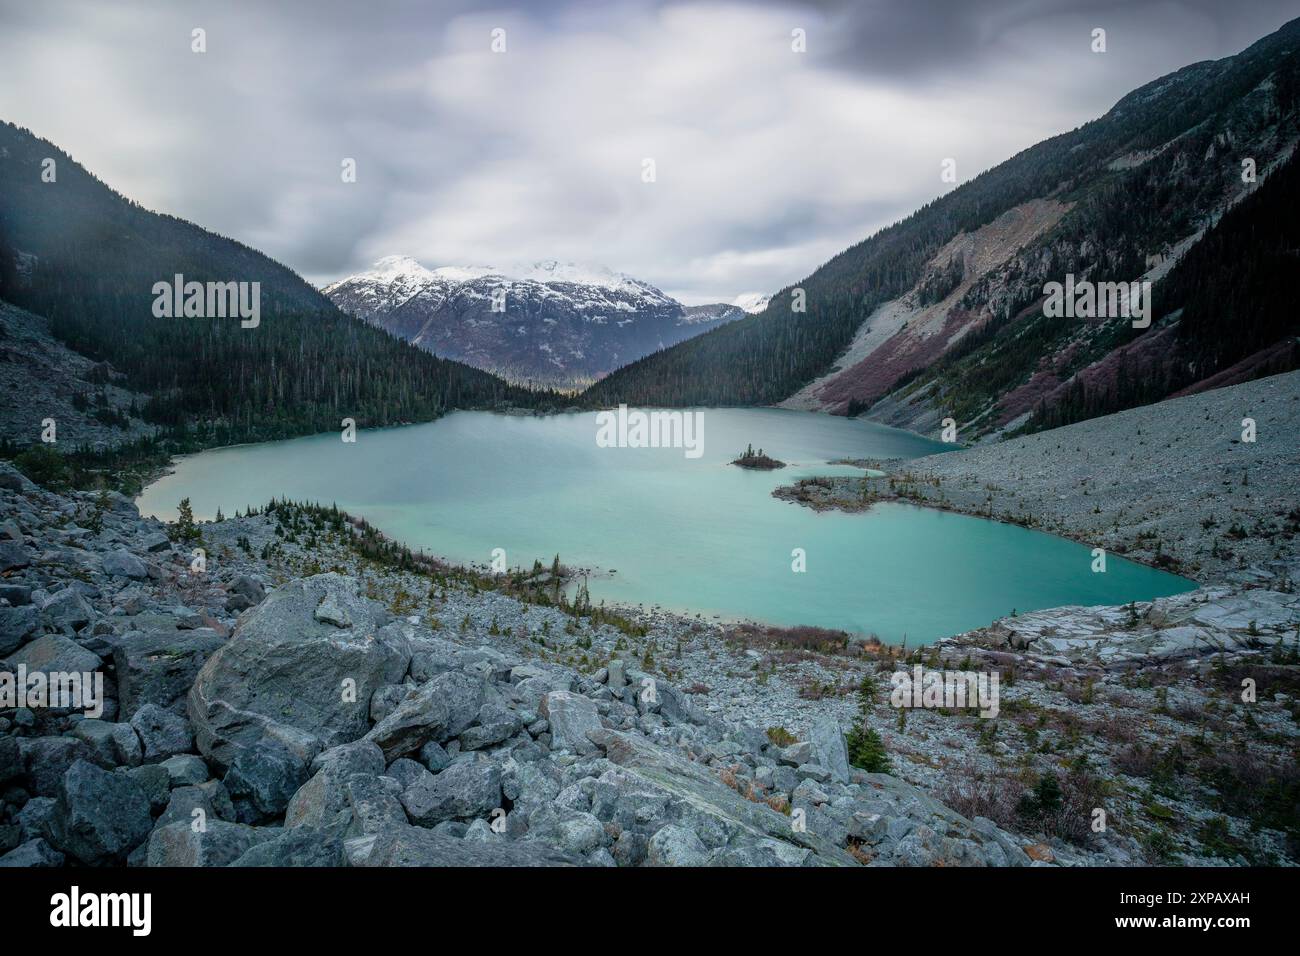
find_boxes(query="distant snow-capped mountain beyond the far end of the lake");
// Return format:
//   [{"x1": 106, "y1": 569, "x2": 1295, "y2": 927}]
[{"x1": 324, "y1": 256, "x2": 745, "y2": 388}]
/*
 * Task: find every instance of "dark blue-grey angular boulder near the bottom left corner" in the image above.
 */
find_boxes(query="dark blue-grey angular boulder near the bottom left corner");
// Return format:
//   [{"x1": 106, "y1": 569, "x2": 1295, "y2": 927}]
[{"x1": 49, "y1": 760, "x2": 153, "y2": 864}]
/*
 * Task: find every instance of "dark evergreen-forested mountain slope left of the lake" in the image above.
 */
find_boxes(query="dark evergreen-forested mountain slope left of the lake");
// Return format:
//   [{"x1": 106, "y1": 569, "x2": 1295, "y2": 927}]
[{"x1": 0, "y1": 124, "x2": 546, "y2": 444}]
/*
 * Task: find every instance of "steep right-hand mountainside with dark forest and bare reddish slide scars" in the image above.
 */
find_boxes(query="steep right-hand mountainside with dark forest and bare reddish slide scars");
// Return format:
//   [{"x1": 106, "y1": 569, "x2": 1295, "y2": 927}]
[{"x1": 586, "y1": 21, "x2": 1300, "y2": 438}]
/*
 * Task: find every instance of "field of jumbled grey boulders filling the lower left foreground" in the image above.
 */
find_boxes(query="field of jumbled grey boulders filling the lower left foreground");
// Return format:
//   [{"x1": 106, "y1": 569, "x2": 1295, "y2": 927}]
[{"x1": 0, "y1": 466, "x2": 1034, "y2": 866}]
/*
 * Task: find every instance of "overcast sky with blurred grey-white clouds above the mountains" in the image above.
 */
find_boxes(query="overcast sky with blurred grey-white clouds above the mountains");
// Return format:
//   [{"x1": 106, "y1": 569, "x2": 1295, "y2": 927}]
[{"x1": 0, "y1": 0, "x2": 1300, "y2": 303}]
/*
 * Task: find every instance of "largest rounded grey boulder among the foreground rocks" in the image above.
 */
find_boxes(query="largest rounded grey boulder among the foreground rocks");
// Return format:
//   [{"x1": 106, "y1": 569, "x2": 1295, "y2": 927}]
[{"x1": 189, "y1": 574, "x2": 411, "y2": 767}]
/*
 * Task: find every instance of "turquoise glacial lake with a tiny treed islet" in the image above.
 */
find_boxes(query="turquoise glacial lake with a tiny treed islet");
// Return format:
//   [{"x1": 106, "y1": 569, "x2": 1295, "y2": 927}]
[{"x1": 138, "y1": 408, "x2": 1195, "y2": 645}]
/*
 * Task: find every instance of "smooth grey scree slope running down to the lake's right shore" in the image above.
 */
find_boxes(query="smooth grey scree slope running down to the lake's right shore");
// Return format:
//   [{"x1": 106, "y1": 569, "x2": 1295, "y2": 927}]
[{"x1": 774, "y1": 372, "x2": 1300, "y2": 585}]
